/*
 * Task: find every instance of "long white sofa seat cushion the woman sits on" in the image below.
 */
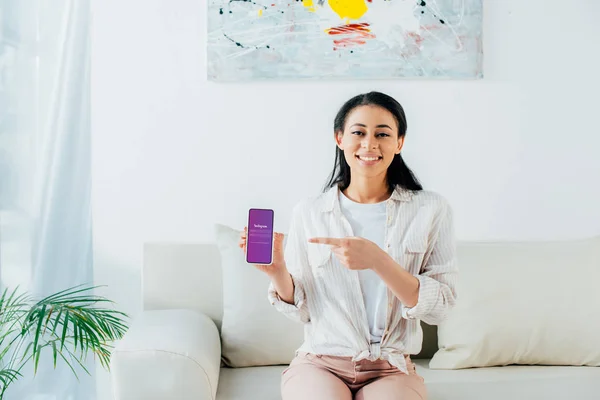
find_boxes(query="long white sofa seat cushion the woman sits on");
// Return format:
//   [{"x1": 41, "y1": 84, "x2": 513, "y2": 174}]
[{"x1": 216, "y1": 360, "x2": 600, "y2": 400}]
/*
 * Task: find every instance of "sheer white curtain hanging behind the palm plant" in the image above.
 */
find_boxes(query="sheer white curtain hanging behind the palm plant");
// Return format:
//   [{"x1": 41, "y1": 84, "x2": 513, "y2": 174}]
[{"x1": 0, "y1": 0, "x2": 95, "y2": 400}]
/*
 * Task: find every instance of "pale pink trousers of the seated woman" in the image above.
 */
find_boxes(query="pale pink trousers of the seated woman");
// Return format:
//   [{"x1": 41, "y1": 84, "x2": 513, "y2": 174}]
[{"x1": 281, "y1": 353, "x2": 427, "y2": 400}]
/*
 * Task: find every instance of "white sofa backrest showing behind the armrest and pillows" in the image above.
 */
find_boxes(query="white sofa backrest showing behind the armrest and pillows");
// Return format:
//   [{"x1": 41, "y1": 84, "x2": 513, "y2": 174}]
[{"x1": 142, "y1": 242, "x2": 438, "y2": 358}]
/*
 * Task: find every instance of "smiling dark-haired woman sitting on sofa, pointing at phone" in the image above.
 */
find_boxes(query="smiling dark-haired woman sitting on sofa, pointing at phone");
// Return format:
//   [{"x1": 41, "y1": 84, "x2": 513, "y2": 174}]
[{"x1": 240, "y1": 92, "x2": 457, "y2": 400}]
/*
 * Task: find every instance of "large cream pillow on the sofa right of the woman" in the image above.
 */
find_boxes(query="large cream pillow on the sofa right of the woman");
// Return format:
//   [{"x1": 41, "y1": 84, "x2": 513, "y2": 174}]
[{"x1": 431, "y1": 237, "x2": 600, "y2": 369}]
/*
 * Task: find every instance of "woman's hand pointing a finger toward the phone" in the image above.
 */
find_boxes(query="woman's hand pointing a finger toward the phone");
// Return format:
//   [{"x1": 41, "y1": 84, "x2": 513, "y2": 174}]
[{"x1": 308, "y1": 237, "x2": 388, "y2": 270}]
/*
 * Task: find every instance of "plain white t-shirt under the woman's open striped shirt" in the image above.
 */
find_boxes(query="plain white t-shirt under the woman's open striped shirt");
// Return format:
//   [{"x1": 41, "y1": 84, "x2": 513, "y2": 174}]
[{"x1": 334, "y1": 191, "x2": 387, "y2": 343}]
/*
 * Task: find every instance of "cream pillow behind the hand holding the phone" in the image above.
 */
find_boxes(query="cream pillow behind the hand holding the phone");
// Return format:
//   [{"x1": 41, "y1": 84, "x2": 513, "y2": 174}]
[{"x1": 215, "y1": 224, "x2": 304, "y2": 367}]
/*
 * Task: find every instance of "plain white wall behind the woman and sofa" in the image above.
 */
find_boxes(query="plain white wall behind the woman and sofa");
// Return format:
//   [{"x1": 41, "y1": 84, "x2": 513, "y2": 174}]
[{"x1": 92, "y1": 0, "x2": 600, "y2": 400}]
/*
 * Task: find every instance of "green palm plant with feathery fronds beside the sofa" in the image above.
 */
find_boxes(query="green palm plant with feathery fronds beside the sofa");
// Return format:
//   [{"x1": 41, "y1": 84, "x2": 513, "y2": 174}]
[{"x1": 0, "y1": 285, "x2": 128, "y2": 400}]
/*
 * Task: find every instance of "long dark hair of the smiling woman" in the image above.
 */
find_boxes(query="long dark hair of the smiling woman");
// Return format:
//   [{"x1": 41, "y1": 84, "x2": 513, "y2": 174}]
[{"x1": 324, "y1": 92, "x2": 423, "y2": 195}]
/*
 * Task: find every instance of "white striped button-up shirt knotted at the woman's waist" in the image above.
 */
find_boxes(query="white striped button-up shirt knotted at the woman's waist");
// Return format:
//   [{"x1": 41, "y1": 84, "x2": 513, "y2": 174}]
[{"x1": 268, "y1": 186, "x2": 458, "y2": 373}]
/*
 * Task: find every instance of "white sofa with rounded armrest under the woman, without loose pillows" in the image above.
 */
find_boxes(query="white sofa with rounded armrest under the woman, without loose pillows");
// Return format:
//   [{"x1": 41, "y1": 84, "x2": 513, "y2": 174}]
[{"x1": 111, "y1": 233, "x2": 600, "y2": 400}]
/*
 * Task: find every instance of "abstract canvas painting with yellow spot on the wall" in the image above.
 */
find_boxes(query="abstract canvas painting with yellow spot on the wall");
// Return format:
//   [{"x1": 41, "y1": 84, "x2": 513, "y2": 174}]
[{"x1": 207, "y1": 0, "x2": 483, "y2": 81}]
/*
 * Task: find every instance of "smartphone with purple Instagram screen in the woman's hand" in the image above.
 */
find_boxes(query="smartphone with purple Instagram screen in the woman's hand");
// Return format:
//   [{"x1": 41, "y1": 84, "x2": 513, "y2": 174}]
[{"x1": 246, "y1": 208, "x2": 275, "y2": 265}]
